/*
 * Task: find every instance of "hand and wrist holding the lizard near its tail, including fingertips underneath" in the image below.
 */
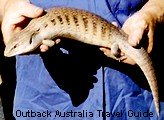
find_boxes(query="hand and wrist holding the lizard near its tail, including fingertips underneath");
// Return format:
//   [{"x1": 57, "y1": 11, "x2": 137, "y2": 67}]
[{"x1": 101, "y1": 0, "x2": 164, "y2": 64}]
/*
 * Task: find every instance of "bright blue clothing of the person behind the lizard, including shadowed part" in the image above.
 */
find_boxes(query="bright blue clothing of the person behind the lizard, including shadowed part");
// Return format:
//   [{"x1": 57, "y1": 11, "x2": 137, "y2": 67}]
[{"x1": 13, "y1": 0, "x2": 164, "y2": 120}]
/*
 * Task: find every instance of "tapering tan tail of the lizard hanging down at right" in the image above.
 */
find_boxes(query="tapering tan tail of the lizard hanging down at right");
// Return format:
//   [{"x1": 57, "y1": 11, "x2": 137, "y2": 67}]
[{"x1": 119, "y1": 44, "x2": 160, "y2": 116}]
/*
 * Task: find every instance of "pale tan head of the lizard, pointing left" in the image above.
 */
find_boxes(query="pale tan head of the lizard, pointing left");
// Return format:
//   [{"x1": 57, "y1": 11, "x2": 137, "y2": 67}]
[{"x1": 4, "y1": 29, "x2": 42, "y2": 57}]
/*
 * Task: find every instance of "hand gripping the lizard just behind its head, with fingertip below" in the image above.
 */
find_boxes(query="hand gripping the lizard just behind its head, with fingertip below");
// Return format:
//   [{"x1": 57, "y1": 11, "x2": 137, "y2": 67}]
[{"x1": 1, "y1": 0, "x2": 57, "y2": 52}]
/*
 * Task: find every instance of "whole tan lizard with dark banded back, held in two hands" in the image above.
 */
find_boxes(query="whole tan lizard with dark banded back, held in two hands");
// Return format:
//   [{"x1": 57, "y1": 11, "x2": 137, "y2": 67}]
[{"x1": 4, "y1": 7, "x2": 159, "y2": 116}]
